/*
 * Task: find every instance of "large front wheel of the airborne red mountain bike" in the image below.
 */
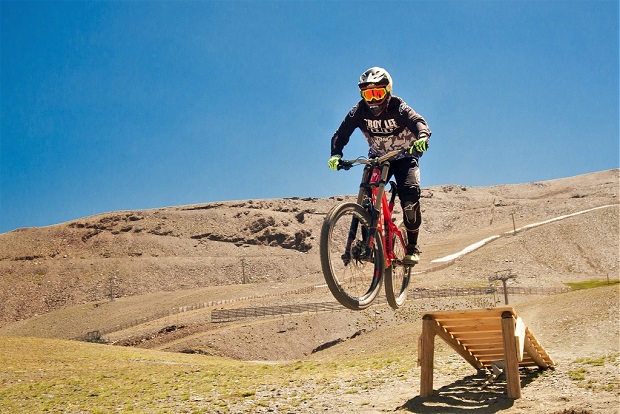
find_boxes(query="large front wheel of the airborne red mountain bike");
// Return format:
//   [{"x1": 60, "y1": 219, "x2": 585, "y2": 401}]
[{"x1": 320, "y1": 203, "x2": 385, "y2": 310}]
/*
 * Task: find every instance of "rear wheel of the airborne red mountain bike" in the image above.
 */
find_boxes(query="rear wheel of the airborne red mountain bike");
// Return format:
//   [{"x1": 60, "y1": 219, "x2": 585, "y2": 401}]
[{"x1": 384, "y1": 223, "x2": 412, "y2": 309}]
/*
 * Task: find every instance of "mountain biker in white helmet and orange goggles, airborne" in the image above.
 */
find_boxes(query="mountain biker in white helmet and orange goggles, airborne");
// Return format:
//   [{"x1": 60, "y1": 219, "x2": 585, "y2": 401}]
[{"x1": 328, "y1": 67, "x2": 431, "y2": 265}]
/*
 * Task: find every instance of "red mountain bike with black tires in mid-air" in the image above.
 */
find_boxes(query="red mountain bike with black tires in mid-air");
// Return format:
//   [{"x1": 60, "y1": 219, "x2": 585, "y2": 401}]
[{"x1": 320, "y1": 150, "x2": 412, "y2": 310}]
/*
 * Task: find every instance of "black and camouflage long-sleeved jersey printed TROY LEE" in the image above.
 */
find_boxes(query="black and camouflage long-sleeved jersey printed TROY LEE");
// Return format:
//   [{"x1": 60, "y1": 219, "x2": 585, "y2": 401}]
[{"x1": 331, "y1": 96, "x2": 431, "y2": 158}]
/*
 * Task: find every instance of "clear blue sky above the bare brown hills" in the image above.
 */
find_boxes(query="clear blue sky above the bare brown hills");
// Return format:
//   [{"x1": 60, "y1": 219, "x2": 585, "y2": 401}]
[{"x1": 0, "y1": 0, "x2": 620, "y2": 232}]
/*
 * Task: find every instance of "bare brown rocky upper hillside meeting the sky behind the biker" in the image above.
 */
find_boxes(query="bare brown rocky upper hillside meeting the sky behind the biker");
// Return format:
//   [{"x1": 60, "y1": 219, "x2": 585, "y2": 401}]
[{"x1": 0, "y1": 170, "x2": 619, "y2": 326}]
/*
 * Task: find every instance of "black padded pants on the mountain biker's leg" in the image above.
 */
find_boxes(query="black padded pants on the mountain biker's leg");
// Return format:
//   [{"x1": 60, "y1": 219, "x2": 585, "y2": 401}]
[{"x1": 388, "y1": 158, "x2": 422, "y2": 248}]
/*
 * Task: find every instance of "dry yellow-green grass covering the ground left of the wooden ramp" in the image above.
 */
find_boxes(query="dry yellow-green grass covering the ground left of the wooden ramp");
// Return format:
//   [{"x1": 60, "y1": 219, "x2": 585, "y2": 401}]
[{"x1": 0, "y1": 337, "x2": 422, "y2": 413}]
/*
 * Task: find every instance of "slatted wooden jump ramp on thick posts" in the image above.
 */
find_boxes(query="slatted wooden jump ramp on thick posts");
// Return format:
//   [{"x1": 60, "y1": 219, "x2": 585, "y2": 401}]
[{"x1": 418, "y1": 306, "x2": 555, "y2": 399}]
